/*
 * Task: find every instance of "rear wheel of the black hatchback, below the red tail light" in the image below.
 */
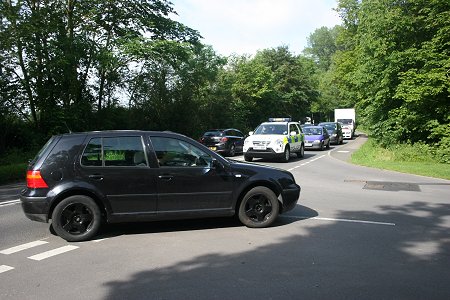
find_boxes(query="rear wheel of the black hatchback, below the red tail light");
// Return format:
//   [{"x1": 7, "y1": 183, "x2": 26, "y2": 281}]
[{"x1": 52, "y1": 195, "x2": 102, "y2": 242}]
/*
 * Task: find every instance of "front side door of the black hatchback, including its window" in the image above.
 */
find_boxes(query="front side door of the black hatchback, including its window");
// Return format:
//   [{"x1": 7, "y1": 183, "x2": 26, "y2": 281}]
[{"x1": 151, "y1": 136, "x2": 234, "y2": 216}]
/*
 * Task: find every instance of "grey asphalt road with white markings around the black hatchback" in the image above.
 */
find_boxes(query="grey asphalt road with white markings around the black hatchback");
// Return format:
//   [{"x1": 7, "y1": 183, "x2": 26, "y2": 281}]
[{"x1": 0, "y1": 138, "x2": 450, "y2": 299}]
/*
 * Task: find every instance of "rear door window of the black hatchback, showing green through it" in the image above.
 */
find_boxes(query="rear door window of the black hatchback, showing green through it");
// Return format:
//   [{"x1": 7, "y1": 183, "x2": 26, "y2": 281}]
[{"x1": 81, "y1": 136, "x2": 148, "y2": 167}]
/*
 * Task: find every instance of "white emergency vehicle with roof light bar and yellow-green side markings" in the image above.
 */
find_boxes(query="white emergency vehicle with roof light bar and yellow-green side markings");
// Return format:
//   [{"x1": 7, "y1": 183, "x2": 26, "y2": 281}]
[{"x1": 244, "y1": 118, "x2": 305, "y2": 162}]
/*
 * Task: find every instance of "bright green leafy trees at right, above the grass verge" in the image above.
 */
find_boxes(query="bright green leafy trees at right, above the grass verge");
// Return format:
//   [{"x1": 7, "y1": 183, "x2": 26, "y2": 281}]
[{"x1": 330, "y1": 0, "x2": 450, "y2": 162}]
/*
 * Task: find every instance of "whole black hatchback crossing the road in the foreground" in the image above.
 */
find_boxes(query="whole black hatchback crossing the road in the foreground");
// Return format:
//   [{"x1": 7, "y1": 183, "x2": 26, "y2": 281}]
[{"x1": 20, "y1": 131, "x2": 300, "y2": 241}]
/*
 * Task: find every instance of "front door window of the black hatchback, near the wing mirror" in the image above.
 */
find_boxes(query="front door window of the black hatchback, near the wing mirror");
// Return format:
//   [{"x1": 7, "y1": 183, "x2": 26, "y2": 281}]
[{"x1": 151, "y1": 137, "x2": 212, "y2": 168}]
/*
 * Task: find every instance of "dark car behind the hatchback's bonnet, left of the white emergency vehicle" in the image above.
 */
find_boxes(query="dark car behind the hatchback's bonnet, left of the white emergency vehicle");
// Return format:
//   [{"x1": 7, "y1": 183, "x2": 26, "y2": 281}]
[{"x1": 200, "y1": 128, "x2": 245, "y2": 156}]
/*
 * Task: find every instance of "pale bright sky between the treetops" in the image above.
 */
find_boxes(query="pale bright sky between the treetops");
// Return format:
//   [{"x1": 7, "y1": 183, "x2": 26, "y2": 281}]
[{"x1": 172, "y1": 0, "x2": 341, "y2": 56}]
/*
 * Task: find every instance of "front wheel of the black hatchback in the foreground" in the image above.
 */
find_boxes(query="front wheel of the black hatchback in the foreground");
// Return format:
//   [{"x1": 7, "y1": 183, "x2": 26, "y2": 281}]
[{"x1": 238, "y1": 186, "x2": 280, "y2": 228}]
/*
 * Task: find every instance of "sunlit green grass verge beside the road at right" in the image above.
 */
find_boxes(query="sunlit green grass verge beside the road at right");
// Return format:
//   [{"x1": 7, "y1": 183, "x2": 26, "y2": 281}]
[{"x1": 351, "y1": 138, "x2": 450, "y2": 179}]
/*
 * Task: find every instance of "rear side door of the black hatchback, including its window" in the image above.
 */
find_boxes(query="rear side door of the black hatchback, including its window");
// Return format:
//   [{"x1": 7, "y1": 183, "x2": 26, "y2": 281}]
[{"x1": 80, "y1": 135, "x2": 158, "y2": 217}]
